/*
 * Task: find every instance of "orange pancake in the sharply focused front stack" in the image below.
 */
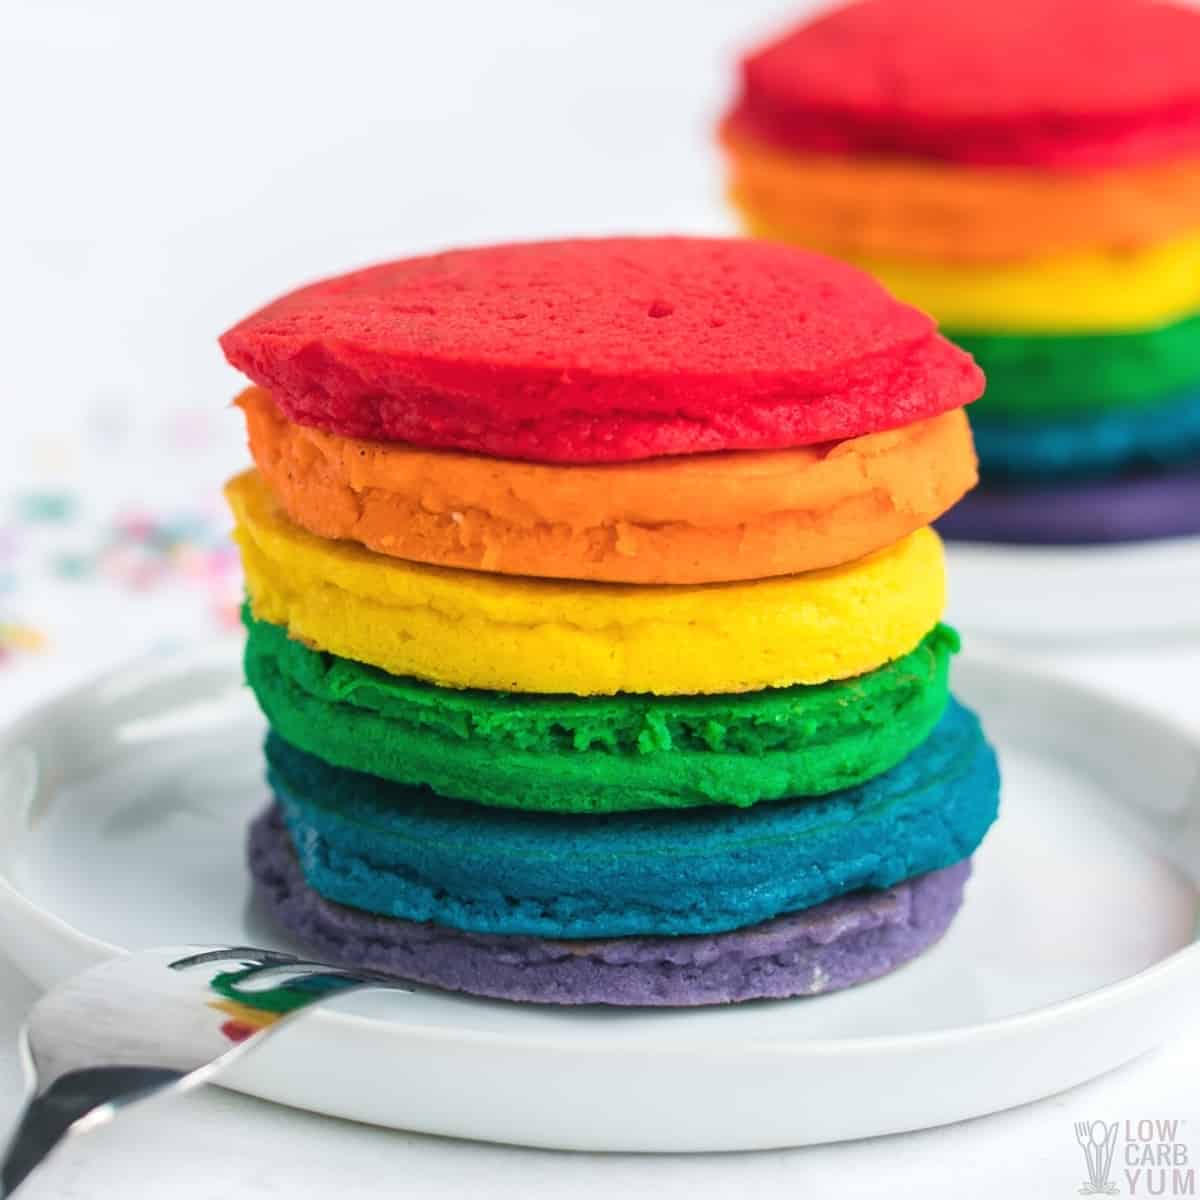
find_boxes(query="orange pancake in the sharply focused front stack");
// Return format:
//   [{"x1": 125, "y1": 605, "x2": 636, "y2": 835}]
[{"x1": 238, "y1": 388, "x2": 976, "y2": 584}]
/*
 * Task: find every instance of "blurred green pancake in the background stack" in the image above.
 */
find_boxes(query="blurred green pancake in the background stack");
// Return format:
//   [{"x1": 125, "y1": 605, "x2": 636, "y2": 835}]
[{"x1": 946, "y1": 316, "x2": 1200, "y2": 424}]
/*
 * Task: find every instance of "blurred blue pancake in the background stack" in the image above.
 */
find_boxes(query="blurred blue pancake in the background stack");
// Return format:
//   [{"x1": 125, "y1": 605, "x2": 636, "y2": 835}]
[{"x1": 971, "y1": 391, "x2": 1200, "y2": 484}]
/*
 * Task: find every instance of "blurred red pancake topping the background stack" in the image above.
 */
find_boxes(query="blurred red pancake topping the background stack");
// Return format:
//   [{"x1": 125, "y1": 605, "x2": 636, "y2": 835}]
[{"x1": 730, "y1": 0, "x2": 1200, "y2": 168}]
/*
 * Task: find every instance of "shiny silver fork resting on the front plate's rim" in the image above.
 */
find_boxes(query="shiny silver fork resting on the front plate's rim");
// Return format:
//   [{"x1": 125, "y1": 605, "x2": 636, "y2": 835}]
[{"x1": 0, "y1": 946, "x2": 412, "y2": 1200}]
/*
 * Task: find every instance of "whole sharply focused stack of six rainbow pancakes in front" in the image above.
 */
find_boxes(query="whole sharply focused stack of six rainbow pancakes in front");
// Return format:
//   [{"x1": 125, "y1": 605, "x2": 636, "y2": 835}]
[{"x1": 222, "y1": 238, "x2": 1000, "y2": 1006}]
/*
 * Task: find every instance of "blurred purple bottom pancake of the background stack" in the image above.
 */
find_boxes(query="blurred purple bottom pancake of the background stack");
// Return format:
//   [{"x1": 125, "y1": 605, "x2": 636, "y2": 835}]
[{"x1": 937, "y1": 463, "x2": 1200, "y2": 546}]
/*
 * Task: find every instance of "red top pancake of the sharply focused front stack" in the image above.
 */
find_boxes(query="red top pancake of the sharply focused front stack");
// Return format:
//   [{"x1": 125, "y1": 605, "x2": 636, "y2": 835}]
[{"x1": 221, "y1": 238, "x2": 983, "y2": 462}]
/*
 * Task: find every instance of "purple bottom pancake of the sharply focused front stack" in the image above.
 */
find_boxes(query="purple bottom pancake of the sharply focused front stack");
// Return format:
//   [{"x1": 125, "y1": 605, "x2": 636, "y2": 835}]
[{"x1": 250, "y1": 808, "x2": 971, "y2": 1007}]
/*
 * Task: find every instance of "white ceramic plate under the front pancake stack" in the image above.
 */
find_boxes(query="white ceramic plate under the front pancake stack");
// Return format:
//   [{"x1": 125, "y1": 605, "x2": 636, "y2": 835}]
[{"x1": 0, "y1": 648, "x2": 1200, "y2": 1151}]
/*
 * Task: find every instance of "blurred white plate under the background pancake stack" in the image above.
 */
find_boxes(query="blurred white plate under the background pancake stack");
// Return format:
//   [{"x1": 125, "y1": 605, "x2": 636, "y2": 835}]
[{"x1": 946, "y1": 538, "x2": 1200, "y2": 648}]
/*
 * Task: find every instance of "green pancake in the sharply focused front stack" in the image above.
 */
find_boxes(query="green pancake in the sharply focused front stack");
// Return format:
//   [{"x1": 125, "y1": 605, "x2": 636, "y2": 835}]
[{"x1": 245, "y1": 612, "x2": 959, "y2": 812}]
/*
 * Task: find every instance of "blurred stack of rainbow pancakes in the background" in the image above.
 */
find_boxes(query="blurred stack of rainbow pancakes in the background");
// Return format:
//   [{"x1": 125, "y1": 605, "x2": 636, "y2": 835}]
[{"x1": 721, "y1": 0, "x2": 1200, "y2": 544}]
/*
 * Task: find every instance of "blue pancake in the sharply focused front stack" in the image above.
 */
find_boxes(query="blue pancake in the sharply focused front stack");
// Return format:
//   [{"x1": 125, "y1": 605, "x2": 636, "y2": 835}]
[{"x1": 266, "y1": 700, "x2": 1000, "y2": 938}]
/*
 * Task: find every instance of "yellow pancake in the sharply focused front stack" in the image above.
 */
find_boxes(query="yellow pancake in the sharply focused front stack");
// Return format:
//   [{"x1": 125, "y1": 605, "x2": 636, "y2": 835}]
[{"x1": 226, "y1": 472, "x2": 946, "y2": 696}]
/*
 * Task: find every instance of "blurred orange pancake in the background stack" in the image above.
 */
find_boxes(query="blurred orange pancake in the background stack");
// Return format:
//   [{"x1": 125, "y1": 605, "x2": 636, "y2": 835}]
[{"x1": 721, "y1": 125, "x2": 1200, "y2": 263}]
